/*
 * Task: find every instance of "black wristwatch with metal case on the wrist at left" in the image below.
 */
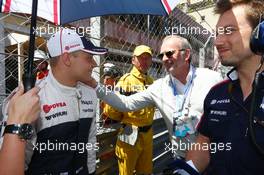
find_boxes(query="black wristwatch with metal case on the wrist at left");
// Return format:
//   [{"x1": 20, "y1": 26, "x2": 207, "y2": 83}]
[{"x1": 4, "y1": 123, "x2": 34, "y2": 140}]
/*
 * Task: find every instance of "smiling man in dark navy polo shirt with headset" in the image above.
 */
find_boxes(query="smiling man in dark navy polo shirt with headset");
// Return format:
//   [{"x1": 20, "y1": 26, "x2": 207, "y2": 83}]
[{"x1": 186, "y1": 0, "x2": 264, "y2": 175}]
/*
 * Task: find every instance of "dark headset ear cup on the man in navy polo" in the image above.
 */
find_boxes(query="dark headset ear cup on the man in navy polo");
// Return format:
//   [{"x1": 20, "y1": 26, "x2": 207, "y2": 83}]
[{"x1": 250, "y1": 20, "x2": 264, "y2": 56}]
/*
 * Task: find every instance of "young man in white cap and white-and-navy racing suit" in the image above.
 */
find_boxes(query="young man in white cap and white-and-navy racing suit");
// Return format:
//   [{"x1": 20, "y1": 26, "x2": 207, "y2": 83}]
[{"x1": 1, "y1": 29, "x2": 107, "y2": 175}]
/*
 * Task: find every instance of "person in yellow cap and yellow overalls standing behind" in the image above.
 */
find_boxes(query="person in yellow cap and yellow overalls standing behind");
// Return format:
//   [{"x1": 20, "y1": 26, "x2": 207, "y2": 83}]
[{"x1": 104, "y1": 45, "x2": 154, "y2": 175}]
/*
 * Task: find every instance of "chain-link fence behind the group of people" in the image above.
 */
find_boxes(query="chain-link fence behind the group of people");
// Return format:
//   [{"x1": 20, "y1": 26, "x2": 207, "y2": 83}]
[{"x1": 0, "y1": 1, "x2": 219, "y2": 172}]
